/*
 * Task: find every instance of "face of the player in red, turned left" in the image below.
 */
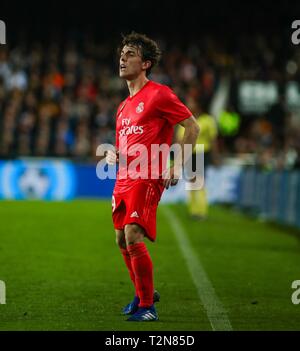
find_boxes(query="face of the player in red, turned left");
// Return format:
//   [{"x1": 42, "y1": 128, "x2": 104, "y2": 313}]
[{"x1": 119, "y1": 45, "x2": 147, "y2": 80}]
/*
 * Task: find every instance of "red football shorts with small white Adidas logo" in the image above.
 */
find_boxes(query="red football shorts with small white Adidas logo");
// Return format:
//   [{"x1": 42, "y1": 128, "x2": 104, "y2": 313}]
[{"x1": 112, "y1": 182, "x2": 163, "y2": 241}]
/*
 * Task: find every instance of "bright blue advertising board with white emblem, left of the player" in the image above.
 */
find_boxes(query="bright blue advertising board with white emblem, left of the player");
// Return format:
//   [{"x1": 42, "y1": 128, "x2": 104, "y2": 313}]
[{"x1": 0, "y1": 159, "x2": 115, "y2": 201}]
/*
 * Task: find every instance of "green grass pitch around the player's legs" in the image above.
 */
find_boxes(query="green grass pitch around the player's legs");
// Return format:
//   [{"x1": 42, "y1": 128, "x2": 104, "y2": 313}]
[{"x1": 0, "y1": 201, "x2": 300, "y2": 331}]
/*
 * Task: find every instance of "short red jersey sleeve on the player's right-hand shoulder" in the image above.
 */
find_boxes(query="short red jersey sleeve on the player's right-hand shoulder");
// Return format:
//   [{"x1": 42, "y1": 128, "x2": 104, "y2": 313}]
[{"x1": 157, "y1": 86, "x2": 193, "y2": 125}]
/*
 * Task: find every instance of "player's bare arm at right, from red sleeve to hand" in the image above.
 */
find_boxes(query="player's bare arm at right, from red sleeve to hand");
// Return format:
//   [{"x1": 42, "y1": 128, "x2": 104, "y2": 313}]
[{"x1": 164, "y1": 116, "x2": 200, "y2": 189}]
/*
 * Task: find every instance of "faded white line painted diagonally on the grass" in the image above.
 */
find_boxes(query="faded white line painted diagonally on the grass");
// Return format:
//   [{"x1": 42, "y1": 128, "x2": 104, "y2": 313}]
[{"x1": 161, "y1": 206, "x2": 232, "y2": 331}]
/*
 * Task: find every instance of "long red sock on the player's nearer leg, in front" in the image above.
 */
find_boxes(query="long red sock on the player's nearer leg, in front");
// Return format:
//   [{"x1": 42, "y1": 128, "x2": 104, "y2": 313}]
[{"x1": 127, "y1": 243, "x2": 154, "y2": 307}]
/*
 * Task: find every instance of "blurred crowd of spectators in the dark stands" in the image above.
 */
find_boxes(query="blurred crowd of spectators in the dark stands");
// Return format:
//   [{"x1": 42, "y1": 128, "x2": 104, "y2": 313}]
[{"x1": 0, "y1": 30, "x2": 300, "y2": 169}]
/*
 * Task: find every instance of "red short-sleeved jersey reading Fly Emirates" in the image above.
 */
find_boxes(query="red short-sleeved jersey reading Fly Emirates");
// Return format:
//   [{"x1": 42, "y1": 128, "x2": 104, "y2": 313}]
[{"x1": 114, "y1": 81, "x2": 192, "y2": 193}]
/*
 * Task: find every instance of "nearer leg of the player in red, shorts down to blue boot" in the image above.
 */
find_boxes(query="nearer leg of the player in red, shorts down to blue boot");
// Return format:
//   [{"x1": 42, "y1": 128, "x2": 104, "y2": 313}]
[{"x1": 123, "y1": 183, "x2": 159, "y2": 321}]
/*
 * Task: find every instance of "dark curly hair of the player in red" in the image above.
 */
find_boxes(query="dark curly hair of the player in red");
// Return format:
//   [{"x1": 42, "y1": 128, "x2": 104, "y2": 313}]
[{"x1": 118, "y1": 32, "x2": 161, "y2": 76}]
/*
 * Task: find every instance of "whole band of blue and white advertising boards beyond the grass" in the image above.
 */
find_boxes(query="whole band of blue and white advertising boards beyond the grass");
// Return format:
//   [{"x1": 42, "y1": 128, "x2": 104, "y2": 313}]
[{"x1": 0, "y1": 159, "x2": 300, "y2": 231}]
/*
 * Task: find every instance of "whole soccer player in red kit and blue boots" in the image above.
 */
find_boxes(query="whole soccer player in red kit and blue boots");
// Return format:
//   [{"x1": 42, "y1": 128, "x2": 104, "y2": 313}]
[{"x1": 106, "y1": 32, "x2": 199, "y2": 321}]
